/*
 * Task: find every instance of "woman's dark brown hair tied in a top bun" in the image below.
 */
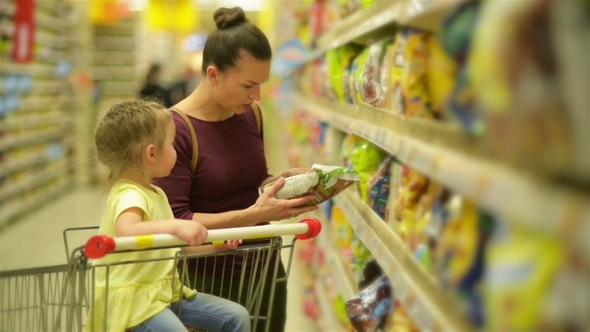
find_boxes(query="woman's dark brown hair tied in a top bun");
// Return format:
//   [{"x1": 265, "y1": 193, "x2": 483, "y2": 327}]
[{"x1": 201, "y1": 7, "x2": 272, "y2": 75}]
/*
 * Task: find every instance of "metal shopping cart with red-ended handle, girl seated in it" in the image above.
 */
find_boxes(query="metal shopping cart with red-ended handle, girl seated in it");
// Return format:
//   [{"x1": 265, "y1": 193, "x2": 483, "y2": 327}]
[{"x1": 0, "y1": 218, "x2": 321, "y2": 332}]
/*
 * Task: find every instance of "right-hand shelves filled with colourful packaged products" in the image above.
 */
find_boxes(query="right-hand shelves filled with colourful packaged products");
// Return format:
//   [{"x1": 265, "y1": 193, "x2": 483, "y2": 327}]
[{"x1": 284, "y1": 0, "x2": 590, "y2": 331}]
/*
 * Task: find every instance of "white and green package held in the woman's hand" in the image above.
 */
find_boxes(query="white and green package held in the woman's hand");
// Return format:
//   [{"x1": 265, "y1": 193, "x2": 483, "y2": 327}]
[{"x1": 262, "y1": 164, "x2": 359, "y2": 205}]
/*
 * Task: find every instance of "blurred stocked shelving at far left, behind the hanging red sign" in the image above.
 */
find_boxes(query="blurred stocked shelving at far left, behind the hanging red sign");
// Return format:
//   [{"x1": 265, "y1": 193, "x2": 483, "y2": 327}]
[{"x1": 0, "y1": 0, "x2": 76, "y2": 227}]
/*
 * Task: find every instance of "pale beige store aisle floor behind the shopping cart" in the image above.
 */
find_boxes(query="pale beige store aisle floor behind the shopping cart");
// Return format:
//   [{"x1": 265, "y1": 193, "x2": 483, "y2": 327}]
[{"x1": 0, "y1": 188, "x2": 318, "y2": 332}]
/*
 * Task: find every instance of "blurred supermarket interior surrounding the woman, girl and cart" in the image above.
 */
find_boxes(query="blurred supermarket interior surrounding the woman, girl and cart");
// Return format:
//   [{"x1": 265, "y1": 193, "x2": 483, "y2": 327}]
[{"x1": 0, "y1": 0, "x2": 590, "y2": 332}]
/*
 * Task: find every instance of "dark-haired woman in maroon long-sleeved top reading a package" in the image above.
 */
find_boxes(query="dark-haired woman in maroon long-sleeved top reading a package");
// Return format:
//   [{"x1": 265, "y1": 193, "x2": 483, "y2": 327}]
[{"x1": 158, "y1": 7, "x2": 317, "y2": 332}]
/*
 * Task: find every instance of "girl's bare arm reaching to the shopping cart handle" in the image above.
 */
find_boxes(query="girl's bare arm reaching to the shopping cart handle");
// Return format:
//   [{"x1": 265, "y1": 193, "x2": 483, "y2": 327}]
[{"x1": 115, "y1": 207, "x2": 207, "y2": 246}]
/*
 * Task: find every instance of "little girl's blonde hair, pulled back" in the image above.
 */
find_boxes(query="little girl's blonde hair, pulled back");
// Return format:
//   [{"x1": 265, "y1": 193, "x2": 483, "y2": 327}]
[{"x1": 94, "y1": 100, "x2": 172, "y2": 184}]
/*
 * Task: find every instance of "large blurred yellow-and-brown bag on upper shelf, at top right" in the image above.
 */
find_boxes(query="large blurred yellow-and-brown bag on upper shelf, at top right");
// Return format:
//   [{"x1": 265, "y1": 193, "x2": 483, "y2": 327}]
[{"x1": 467, "y1": 1, "x2": 590, "y2": 179}]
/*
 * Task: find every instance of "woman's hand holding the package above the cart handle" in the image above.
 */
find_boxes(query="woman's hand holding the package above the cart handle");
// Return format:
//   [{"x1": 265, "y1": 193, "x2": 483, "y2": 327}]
[{"x1": 251, "y1": 177, "x2": 318, "y2": 222}]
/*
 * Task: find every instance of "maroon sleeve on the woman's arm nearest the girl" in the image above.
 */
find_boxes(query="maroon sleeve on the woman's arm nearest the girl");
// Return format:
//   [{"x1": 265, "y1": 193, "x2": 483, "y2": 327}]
[{"x1": 156, "y1": 113, "x2": 194, "y2": 220}]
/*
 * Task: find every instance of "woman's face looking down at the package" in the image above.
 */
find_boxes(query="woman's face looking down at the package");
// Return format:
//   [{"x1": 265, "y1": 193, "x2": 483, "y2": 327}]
[{"x1": 215, "y1": 52, "x2": 270, "y2": 114}]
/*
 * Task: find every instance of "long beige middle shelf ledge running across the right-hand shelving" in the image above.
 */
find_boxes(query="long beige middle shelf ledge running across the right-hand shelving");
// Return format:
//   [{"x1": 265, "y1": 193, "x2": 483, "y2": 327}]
[{"x1": 295, "y1": 95, "x2": 590, "y2": 258}]
